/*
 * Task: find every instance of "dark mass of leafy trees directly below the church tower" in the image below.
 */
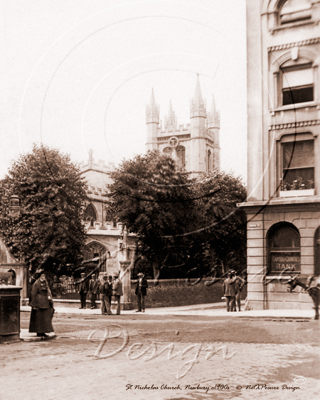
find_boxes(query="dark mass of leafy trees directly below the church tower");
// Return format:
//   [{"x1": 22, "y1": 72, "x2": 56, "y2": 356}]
[{"x1": 108, "y1": 152, "x2": 246, "y2": 277}]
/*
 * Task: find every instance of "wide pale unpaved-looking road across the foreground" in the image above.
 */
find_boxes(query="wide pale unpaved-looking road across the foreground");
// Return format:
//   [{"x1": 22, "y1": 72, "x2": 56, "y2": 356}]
[{"x1": 0, "y1": 313, "x2": 320, "y2": 400}]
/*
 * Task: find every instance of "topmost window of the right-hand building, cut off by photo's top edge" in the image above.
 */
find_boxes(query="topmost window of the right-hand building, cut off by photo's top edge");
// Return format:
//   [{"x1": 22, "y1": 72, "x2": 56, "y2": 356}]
[{"x1": 279, "y1": 0, "x2": 312, "y2": 25}]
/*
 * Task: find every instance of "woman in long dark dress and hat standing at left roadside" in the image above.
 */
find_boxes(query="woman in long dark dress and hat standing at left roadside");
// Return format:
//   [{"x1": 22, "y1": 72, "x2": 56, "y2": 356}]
[{"x1": 29, "y1": 273, "x2": 54, "y2": 337}]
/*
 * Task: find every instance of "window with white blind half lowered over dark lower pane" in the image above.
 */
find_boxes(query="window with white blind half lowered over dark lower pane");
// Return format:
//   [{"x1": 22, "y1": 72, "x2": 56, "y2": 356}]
[{"x1": 281, "y1": 64, "x2": 314, "y2": 106}]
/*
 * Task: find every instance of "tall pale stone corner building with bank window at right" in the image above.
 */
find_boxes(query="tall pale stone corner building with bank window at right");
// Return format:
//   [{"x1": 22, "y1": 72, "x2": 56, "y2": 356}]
[{"x1": 244, "y1": 0, "x2": 320, "y2": 309}]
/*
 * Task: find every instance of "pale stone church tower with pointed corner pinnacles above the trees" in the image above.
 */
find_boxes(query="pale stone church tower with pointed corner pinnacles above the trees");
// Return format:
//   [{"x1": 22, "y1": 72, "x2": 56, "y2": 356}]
[{"x1": 146, "y1": 75, "x2": 220, "y2": 174}]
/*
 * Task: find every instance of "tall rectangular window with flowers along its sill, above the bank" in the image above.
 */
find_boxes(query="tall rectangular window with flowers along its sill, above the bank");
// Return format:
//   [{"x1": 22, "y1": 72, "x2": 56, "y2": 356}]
[{"x1": 281, "y1": 140, "x2": 314, "y2": 191}]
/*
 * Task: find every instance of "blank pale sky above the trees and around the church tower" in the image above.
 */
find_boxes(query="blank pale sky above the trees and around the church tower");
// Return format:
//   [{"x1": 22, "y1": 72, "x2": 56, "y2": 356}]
[{"x1": 0, "y1": 0, "x2": 247, "y2": 181}]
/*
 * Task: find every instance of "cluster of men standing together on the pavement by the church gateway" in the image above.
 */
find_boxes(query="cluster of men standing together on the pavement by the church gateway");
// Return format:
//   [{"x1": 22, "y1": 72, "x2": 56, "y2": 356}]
[{"x1": 77, "y1": 273, "x2": 123, "y2": 315}]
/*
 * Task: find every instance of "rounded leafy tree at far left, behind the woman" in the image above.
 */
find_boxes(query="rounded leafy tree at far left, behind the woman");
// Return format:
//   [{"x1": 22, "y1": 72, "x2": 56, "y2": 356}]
[{"x1": 1, "y1": 145, "x2": 86, "y2": 273}]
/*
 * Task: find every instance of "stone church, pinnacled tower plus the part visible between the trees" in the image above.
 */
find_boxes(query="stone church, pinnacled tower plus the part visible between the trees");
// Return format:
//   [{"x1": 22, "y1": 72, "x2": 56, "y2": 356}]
[{"x1": 81, "y1": 76, "x2": 220, "y2": 282}]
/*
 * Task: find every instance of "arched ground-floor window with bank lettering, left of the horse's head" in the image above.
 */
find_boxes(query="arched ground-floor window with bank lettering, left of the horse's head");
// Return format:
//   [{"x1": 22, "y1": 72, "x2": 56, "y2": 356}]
[{"x1": 267, "y1": 223, "x2": 301, "y2": 274}]
